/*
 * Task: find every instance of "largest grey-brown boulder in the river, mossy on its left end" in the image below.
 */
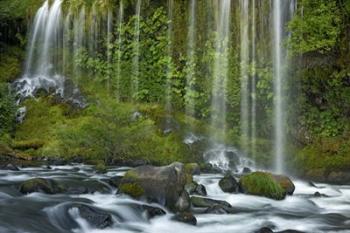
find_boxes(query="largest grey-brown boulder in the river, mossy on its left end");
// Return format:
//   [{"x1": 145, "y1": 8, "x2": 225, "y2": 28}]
[{"x1": 119, "y1": 163, "x2": 186, "y2": 210}]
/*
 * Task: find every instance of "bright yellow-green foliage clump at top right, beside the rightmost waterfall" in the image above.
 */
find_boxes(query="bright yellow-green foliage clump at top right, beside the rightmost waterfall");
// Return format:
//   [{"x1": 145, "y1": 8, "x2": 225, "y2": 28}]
[{"x1": 289, "y1": 0, "x2": 341, "y2": 54}]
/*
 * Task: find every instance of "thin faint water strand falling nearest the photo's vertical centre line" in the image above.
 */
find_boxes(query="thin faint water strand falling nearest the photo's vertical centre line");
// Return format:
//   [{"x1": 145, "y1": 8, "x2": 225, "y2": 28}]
[{"x1": 165, "y1": 0, "x2": 174, "y2": 113}]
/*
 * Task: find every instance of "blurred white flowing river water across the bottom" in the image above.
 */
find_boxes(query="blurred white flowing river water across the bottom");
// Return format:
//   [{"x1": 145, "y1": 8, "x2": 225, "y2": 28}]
[{"x1": 0, "y1": 164, "x2": 350, "y2": 233}]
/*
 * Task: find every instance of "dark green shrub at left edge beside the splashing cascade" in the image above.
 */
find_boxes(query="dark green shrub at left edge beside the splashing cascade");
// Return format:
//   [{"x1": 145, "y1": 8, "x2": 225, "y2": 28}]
[{"x1": 0, "y1": 83, "x2": 17, "y2": 136}]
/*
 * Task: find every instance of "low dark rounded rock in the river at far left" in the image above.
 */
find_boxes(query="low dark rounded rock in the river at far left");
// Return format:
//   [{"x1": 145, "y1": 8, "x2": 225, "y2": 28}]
[{"x1": 19, "y1": 178, "x2": 65, "y2": 194}]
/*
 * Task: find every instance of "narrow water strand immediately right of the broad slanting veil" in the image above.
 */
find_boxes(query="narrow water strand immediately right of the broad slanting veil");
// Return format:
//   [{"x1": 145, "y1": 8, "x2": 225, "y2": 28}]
[{"x1": 240, "y1": 0, "x2": 249, "y2": 147}]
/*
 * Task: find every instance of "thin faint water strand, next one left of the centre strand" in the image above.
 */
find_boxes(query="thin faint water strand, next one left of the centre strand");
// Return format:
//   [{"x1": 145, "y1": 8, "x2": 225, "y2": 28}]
[{"x1": 132, "y1": 0, "x2": 141, "y2": 98}]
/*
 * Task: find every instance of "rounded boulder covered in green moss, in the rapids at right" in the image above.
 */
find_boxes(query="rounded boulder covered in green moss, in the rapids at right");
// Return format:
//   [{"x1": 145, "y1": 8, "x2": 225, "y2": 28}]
[{"x1": 239, "y1": 172, "x2": 287, "y2": 200}]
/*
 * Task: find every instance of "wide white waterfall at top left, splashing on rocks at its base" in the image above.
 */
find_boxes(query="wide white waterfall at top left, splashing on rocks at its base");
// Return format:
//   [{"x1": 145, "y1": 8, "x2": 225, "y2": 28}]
[{"x1": 16, "y1": 0, "x2": 64, "y2": 96}]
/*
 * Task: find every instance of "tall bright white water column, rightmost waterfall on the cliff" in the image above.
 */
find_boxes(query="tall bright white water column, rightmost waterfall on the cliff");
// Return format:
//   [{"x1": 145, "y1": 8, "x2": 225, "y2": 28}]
[{"x1": 272, "y1": 0, "x2": 295, "y2": 173}]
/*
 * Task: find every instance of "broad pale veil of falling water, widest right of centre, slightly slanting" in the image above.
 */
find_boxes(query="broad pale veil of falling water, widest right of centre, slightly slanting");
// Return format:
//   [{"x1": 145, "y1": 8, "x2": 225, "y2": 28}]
[{"x1": 211, "y1": 0, "x2": 231, "y2": 141}]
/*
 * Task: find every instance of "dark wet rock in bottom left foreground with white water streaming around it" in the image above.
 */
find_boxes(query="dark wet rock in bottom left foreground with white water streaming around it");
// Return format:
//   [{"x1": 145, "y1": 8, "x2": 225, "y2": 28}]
[{"x1": 73, "y1": 204, "x2": 113, "y2": 229}]
